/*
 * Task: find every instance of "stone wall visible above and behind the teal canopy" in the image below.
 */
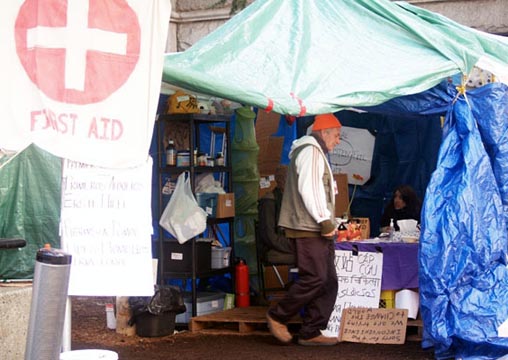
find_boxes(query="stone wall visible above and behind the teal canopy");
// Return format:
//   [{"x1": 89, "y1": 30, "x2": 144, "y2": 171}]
[{"x1": 170, "y1": 0, "x2": 508, "y2": 52}]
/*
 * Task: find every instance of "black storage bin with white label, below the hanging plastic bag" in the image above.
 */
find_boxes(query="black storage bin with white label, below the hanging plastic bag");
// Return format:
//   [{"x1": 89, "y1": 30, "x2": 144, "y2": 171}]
[{"x1": 163, "y1": 239, "x2": 212, "y2": 272}]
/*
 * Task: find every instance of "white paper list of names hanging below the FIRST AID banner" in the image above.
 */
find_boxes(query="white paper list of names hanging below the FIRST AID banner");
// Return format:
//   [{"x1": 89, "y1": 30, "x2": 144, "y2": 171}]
[{"x1": 60, "y1": 159, "x2": 154, "y2": 296}]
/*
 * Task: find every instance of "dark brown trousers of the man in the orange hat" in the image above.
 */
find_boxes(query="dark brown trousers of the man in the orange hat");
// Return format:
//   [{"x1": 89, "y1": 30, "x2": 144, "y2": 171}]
[{"x1": 268, "y1": 237, "x2": 338, "y2": 339}]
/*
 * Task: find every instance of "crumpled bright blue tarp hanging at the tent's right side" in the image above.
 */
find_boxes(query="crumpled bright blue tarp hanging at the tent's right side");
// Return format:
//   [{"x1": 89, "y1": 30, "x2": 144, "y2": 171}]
[{"x1": 420, "y1": 84, "x2": 508, "y2": 359}]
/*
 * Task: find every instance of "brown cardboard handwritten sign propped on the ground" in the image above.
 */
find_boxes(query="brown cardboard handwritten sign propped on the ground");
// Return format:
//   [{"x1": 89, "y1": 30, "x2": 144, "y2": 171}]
[{"x1": 339, "y1": 308, "x2": 407, "y2": 344}]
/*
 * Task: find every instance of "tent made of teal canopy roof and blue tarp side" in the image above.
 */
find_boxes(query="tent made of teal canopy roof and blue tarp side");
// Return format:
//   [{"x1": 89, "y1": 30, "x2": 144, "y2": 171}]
[{"x1": 163, "y1": 0, "x2": 508, "y2": 359}]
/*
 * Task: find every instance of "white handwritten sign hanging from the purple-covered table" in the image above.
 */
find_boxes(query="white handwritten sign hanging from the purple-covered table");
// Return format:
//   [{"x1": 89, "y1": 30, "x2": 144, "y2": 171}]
[{"x1": 325, "y1": 250, "x2": 383, "y2": 337}]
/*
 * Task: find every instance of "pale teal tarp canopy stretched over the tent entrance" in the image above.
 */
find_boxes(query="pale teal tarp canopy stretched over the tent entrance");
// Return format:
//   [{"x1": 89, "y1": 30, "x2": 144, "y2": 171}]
[{"x1": 163, "y1": 0, "x2": 508, "y2": 116}]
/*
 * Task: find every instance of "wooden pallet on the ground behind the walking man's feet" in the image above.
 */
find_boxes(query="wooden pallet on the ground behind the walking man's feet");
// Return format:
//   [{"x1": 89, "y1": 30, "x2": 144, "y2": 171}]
[{"x1": 189, "y1": 306, "x2": 302, "y2": 335}]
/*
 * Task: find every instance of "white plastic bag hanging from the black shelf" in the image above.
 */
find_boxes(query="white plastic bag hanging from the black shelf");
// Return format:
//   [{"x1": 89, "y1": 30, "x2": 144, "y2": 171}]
[{"x1": 159, "y1": 172, "x2": 207, "y2": 244}]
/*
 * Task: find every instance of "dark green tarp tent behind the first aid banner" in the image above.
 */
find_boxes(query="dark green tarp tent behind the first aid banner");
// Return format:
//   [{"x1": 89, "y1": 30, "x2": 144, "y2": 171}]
[{"x1": 0, "y1": 145, "x2": 62, "y2": 280}]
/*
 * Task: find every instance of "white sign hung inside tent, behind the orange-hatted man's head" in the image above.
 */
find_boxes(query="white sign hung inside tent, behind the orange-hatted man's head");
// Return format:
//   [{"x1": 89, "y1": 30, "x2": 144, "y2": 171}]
[{"x1": 330, "y1": 126, "x2": 376, "y2": 185}]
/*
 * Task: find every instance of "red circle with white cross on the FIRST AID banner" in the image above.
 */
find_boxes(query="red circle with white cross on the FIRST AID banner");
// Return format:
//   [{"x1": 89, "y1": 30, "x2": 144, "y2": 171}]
[{"x1": 15, "y1": 0, "x2": 140, "y2": 104}]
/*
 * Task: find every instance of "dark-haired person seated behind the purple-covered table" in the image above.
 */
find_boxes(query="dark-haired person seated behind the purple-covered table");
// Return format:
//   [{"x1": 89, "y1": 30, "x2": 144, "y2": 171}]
[{"x1": 381, "y1": 185, "x2": 422, "y2": 232}]
